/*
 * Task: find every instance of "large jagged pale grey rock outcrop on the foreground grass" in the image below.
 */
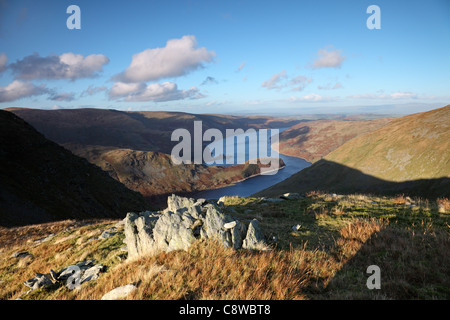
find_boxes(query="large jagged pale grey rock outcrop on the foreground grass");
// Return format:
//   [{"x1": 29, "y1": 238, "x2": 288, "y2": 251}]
[{"x1": 124, "y1": 195, "x2": 265, "y2": 258}]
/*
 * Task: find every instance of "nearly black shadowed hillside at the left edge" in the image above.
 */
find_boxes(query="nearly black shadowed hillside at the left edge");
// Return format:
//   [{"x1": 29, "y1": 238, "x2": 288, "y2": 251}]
[{"x1": 0, "y1": 110, "x2": 148, "y2": 226}]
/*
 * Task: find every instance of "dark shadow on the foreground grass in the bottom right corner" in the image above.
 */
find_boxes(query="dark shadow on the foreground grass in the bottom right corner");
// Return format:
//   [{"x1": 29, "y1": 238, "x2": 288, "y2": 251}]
[{"x1": 307, "y1": 225, "x2": 450, "y2": 300}]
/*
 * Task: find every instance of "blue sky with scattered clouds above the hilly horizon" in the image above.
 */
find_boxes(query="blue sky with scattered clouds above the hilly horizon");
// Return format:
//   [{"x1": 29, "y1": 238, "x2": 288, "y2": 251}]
[{"x1": 0, "y1": 0, "x2": 450, "y2": 115}]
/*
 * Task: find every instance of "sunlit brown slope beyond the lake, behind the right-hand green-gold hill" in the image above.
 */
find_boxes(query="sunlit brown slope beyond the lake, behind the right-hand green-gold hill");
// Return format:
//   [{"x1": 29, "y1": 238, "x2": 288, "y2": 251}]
[{"x1": 279, "y1": 118, "x2": 393, "y2": 162}]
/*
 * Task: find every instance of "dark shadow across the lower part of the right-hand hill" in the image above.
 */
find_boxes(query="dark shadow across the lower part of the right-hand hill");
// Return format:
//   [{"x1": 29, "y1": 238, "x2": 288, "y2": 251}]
[{"x1": 254, "y1": 159, "x2": 450, "y2": 199}]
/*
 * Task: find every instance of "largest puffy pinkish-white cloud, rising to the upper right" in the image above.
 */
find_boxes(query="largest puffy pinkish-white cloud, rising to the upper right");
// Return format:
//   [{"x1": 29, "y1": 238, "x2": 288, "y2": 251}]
[{"x1": 115, "y1": 35, "x2": 216, "y2": 82}]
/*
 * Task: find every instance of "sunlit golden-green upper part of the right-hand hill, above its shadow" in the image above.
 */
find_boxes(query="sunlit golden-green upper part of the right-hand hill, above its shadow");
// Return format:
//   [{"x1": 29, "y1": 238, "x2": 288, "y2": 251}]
[{"x1": 325, "y1": 105, "x2": 450, "y2": 182}]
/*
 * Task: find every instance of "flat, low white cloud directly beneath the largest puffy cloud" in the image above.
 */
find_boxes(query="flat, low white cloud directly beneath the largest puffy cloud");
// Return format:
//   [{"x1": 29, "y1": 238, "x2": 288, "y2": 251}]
[{"x1": 109, "y1": 82, "x2": 204, "y2": 102}]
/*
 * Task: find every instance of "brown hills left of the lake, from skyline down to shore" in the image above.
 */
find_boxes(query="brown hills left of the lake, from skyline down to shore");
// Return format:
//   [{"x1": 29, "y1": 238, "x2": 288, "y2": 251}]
[{"x1": 9, "y1": 108, "x2": 299, "y2": 204}]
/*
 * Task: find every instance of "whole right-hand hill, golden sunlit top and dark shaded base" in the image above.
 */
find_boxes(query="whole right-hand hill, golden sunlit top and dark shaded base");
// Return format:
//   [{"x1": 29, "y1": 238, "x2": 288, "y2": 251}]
[{"x1": 256, "y1": 106, "x2": 450, "y2": 197}]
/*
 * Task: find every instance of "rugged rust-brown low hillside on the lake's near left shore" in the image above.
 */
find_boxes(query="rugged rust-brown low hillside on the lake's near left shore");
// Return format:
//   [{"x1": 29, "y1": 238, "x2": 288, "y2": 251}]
[{"x1": 66, "y1": 145, "x2": 284, "y2": 204}]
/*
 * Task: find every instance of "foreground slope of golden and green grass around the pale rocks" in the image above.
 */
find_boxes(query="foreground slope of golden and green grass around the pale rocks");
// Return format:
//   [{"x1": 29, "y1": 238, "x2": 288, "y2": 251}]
[{"x1": 0, "y1": 194, "x2": 450, "y2": 300}]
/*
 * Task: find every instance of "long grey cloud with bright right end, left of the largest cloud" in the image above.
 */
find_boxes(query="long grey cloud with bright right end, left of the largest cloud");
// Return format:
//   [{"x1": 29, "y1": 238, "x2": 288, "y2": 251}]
[{"x1": 9, "y1": 52, "x2": 109, "y2": 80}]
